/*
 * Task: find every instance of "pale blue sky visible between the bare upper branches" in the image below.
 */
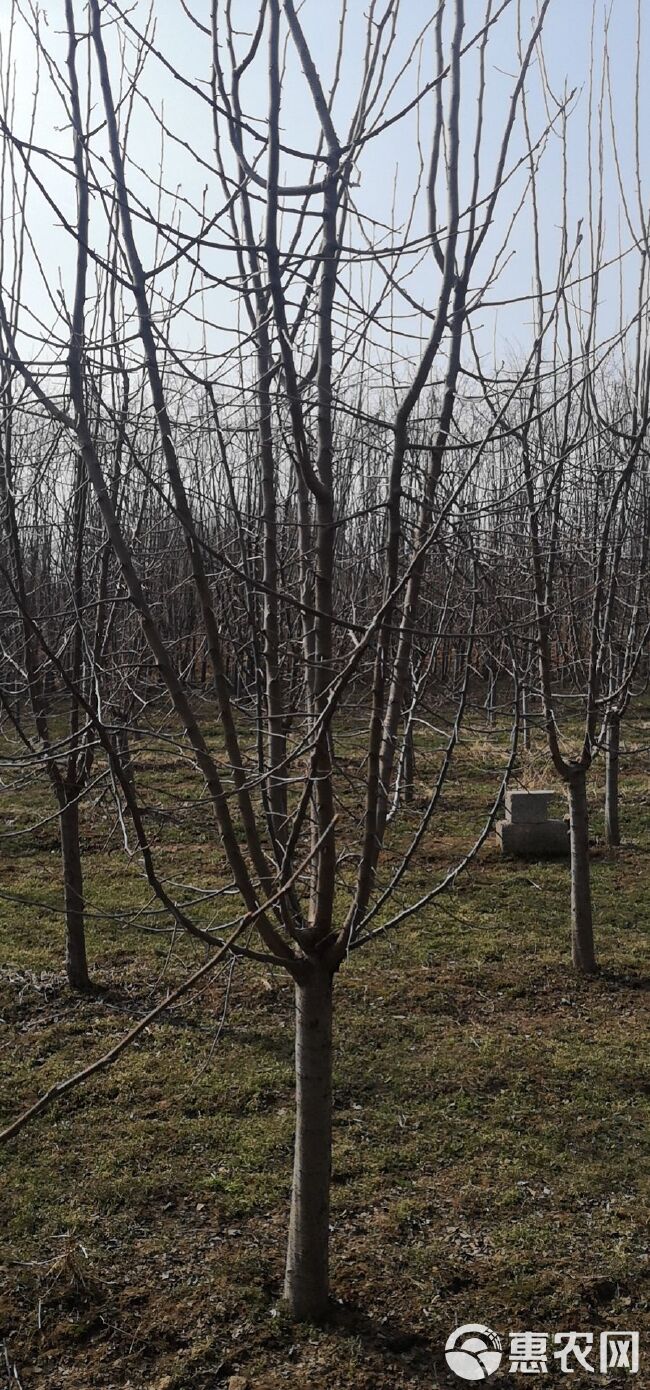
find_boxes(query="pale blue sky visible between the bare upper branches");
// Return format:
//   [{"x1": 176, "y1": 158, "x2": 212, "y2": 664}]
[{"x1": 0, "y1": 0, "x2": 650, "y2": 400}]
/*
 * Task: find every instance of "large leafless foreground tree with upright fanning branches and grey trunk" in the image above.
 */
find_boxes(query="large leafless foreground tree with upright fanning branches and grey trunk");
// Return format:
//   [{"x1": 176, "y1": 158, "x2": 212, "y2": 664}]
[{"x1": 0, "y1": 0, "x2": 615, "y2": 1318}]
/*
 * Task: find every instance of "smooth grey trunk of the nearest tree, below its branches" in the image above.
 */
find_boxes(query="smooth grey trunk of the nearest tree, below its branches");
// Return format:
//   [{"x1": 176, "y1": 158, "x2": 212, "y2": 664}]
[{"x1": 285, "y1": 966, "x2": 332, "y2": 1321}]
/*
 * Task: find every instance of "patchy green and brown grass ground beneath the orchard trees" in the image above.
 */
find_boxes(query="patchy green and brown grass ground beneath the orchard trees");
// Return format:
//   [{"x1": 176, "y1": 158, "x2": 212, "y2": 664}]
[{"x1": 0, "y1": 721, "x2": 650, "y2": 1390}]
